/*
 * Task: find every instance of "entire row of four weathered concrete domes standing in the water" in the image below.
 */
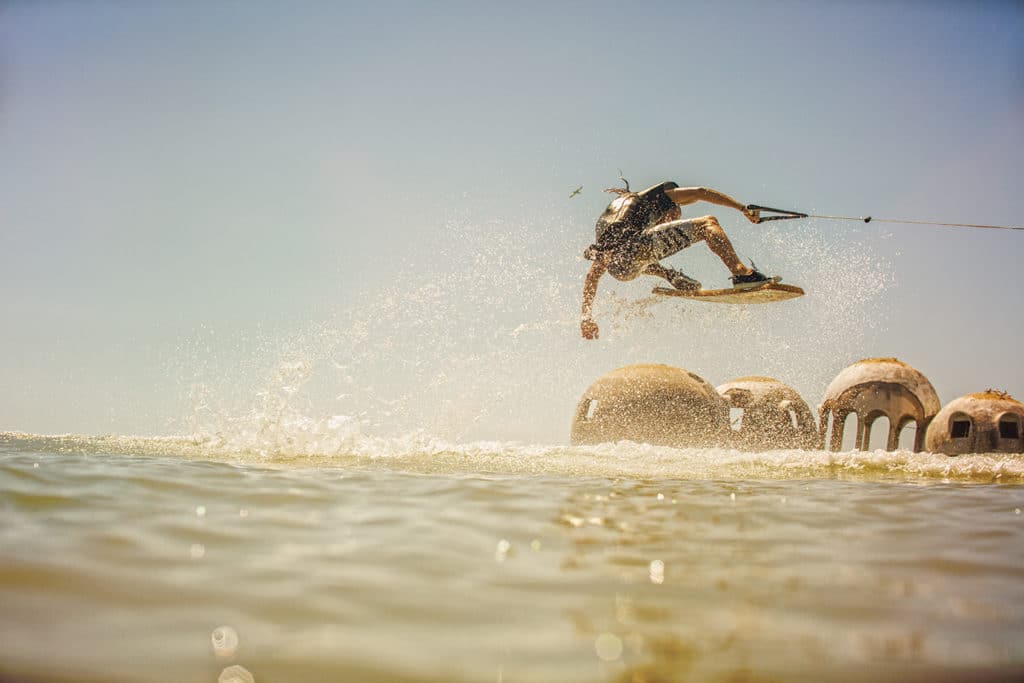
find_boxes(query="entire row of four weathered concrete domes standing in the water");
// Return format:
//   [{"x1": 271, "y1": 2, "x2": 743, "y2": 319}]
[{"x1": 571, "y1": 358, "x2": 1024, "y2": 456}]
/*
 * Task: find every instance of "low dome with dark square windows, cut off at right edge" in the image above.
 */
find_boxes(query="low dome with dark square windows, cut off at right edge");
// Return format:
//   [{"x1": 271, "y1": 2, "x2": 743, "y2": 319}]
[{"x1": 926, "y1": 389, "x2": 1024, "y2": 456}]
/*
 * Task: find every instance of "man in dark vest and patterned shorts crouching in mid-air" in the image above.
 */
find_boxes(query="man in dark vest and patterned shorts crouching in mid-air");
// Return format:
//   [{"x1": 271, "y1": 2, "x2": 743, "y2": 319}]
[{"x1": 580, "y1": 180, "x2": 777, "y2": 339}]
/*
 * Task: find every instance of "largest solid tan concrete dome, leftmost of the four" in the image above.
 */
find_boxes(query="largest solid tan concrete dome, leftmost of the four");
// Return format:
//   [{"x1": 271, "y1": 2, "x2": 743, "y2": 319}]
[{"x1": 571, "y1": 365, "x2": 729, "y2": 447}]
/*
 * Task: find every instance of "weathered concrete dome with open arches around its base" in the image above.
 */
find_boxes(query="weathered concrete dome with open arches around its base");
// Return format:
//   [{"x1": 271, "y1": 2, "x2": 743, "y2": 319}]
[{"x1": 818, "y1": 358, "x2": 940, "y2": 451}]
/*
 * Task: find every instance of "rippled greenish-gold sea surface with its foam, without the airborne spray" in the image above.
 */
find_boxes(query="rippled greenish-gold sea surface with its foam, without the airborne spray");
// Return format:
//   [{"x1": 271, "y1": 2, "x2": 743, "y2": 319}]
[{"x1": 0, "y1": 433, "x2": 1024, "y2": 683}]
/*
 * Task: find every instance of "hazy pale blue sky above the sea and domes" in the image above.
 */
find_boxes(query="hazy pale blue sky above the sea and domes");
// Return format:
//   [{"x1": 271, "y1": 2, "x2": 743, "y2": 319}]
[{"x1": 0, "y1": 0, "x2": 1024, "y2": 442}]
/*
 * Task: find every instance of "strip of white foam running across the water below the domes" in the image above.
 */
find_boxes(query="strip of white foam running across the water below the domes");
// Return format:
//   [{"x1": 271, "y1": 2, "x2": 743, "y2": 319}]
[{"x1": 0, "y1": 432, "x2": 1024, "y2": 484}]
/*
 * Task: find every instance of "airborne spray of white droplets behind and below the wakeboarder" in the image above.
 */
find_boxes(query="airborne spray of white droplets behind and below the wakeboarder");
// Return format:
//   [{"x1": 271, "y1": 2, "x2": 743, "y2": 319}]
[{"x1": 172, "y1": 208, "x2": 892, "y2": 454}]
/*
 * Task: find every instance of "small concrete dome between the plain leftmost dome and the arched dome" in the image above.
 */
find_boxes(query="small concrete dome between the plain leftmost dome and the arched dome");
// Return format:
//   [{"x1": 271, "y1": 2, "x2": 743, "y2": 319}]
[{"x1": 717, "y1": 377, "x2": 819, "y2": 451}]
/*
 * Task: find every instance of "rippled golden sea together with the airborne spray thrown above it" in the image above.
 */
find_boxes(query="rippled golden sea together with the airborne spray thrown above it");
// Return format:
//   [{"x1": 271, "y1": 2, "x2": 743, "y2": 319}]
[{"x1": 0, "y1": 217, "x2": 1024, "y2": 683}]
